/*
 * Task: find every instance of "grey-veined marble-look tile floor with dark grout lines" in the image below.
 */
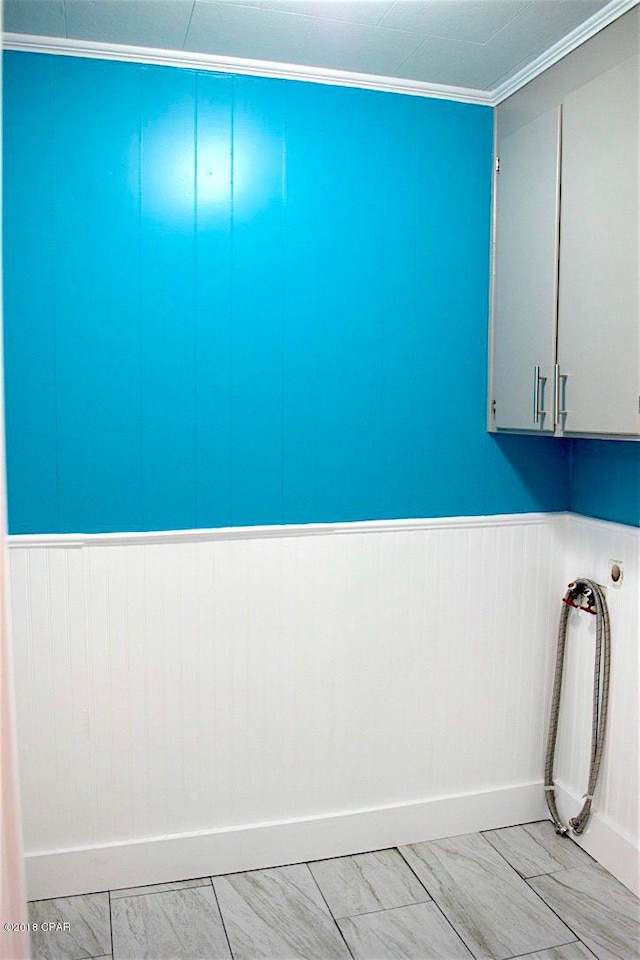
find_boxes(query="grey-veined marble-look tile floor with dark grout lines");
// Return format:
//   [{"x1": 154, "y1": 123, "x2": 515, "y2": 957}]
[{"x1": 29, "y1": 821, "x2": 640, "y2": 960}]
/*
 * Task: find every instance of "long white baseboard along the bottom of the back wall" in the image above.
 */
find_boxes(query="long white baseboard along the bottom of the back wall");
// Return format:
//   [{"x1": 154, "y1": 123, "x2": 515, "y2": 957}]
[{"x1": 26, "y1": 782, "x2": 546, "y2": 900}]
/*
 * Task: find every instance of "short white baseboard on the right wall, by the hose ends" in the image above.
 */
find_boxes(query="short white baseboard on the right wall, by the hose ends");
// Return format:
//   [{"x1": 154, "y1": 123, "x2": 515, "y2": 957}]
[{"x1": 556, "y1": 781, "x2": 640, "y2": 897}]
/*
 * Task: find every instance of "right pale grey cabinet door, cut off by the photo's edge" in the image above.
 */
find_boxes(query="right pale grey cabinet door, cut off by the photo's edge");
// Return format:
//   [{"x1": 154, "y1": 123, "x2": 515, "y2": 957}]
[{"x1": 558, "y1": 57, "x2": 640, "y2": 436}]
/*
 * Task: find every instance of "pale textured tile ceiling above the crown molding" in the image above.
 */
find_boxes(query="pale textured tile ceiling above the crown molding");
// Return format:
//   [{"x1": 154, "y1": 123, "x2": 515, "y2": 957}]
[{"x1": 4, "y1": 0, "x2": 607, "y2": 90}]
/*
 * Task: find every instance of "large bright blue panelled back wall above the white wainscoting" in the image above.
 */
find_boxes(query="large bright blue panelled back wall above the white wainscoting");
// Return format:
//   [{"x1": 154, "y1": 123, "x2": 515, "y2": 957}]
[{"x1": 4, "y1": 53, "x2": 568, "y2": 533}]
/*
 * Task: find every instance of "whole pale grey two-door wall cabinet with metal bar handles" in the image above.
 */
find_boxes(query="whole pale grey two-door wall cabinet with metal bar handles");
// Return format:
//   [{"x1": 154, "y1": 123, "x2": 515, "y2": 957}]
[{"x1": 490, "y1": 56, "x2": 640, "y2": 439}]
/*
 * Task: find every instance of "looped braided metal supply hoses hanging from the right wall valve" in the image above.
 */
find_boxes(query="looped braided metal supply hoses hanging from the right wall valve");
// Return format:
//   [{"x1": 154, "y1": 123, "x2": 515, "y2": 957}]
[{"x1": 544, "y1": 577, "x2": 611, "y2": 835}]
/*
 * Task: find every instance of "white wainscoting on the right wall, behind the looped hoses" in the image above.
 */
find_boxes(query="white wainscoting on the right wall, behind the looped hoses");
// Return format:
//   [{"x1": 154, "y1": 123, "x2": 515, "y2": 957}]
[{"x1": 555, "y1": 514, "x2": 640, "y2": 896}]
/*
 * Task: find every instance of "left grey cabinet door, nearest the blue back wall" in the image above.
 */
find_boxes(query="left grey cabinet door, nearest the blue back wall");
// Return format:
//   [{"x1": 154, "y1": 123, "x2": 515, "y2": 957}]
[{"x1": 492, "y1": 107, "x2": 560, "y2": 433}]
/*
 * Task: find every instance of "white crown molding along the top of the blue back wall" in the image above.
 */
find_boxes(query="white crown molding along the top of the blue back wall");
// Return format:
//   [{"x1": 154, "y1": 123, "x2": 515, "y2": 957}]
[{"x1": 3, "y1": 33, "x2": 492, "y2": 106}]
